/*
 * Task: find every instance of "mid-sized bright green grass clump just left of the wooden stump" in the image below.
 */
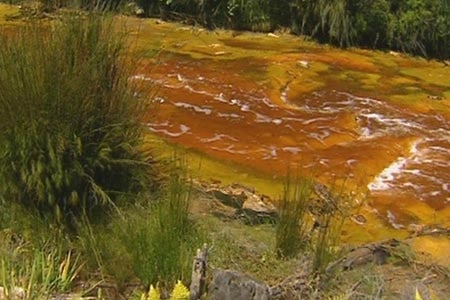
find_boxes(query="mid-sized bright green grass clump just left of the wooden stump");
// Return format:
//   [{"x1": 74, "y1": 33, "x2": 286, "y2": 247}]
[{"x1": 123, "y1": 166, "x2": 202, "y2": 287}]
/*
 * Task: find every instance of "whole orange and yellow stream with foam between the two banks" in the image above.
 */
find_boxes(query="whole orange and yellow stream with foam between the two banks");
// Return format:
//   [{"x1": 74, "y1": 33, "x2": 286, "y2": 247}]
[{"x1": 125, "y1": 17, "x2": 450, "y2": 237}]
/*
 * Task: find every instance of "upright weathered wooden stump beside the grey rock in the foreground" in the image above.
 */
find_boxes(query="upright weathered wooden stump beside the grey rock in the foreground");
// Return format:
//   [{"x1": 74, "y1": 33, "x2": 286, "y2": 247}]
[{"x1": 189, "y1": 244, "x2": 208, "y2": 300}]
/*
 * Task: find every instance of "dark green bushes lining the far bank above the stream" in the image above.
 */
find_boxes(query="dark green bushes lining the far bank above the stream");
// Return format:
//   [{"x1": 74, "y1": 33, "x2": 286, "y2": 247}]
[{"x1": 138, "y1": 0, "x2": 450, "y2": 59}]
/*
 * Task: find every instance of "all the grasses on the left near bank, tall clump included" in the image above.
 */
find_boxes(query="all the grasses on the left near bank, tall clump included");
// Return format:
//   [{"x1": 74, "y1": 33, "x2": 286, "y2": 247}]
[{"x1": 0, "y1": 12, "x2": 202, "y2": 299}]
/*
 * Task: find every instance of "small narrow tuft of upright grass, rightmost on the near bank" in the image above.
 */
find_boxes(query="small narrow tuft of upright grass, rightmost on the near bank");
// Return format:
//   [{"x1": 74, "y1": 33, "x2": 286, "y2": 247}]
[{"x1": 275, "y1": 176, "x2": 312, "y2": 258}]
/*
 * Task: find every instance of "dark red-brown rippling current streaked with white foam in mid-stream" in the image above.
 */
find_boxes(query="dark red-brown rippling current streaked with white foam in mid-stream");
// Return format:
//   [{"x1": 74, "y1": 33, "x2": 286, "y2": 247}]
[{"x1": 139, "y1": 57, "x2": 450, "y2": 224}]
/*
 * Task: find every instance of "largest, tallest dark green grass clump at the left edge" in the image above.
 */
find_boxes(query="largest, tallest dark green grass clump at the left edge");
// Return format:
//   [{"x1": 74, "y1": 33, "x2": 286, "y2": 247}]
[{"x1": 0, "y1": 14, "x2": 152, "y2": 221}]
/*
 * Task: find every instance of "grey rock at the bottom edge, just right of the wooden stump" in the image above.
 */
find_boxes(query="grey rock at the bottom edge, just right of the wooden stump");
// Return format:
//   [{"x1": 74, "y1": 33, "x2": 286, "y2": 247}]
[{"x1": 209, "y1": 270, "x2": 270, "y2": 300}]
